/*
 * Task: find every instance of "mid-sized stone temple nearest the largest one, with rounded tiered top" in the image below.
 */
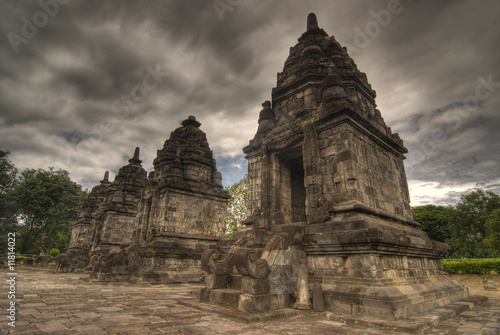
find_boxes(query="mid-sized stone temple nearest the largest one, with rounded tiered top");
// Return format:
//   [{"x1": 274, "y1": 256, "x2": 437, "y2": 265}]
[{"x1": 131, "y1": 116, "x2": 229, "y2": 283}]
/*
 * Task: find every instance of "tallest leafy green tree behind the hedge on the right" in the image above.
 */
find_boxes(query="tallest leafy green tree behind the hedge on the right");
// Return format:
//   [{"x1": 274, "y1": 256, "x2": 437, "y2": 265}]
[{"x1": 446, "y1": 189, "x2": 500, "y2": 258}]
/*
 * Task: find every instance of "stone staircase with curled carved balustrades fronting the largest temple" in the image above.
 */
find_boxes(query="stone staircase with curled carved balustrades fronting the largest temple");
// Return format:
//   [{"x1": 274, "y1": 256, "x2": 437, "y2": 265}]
[{"x1": 200, "y1": 230, "x2": 305, "y2": 313}]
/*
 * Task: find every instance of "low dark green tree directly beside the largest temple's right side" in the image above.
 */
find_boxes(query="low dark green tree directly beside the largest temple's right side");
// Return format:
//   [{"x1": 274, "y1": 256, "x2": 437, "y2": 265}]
[{"x1": 412, "y1": 205, "x2": 452, "y2": 242}]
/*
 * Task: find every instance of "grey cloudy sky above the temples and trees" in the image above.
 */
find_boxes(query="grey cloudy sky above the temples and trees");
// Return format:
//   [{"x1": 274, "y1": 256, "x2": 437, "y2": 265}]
[{"x1": 0, "y1": 0, "x2": 500, "y2": 206}]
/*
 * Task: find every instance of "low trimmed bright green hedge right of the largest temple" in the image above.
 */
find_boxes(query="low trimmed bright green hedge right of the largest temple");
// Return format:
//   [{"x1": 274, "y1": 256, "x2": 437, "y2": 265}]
[{"x1": 443, "y1": 258, "x2": 500, "y2": 275}]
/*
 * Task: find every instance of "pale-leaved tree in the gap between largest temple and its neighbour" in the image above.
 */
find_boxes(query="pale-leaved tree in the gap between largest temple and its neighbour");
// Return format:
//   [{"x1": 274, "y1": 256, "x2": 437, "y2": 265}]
[{"x1": 226, "y1": 176, "x2": 248, "y2": 239}]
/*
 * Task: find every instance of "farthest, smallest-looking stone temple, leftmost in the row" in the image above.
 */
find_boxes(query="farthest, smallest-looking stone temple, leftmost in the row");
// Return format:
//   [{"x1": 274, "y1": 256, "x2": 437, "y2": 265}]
[{"x1": 57, "y1": 171, "x2": 110, "y2": 272}]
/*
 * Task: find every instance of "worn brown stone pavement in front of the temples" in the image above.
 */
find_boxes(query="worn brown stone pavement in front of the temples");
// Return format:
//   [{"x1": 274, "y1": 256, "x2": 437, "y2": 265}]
[{"x1": 0, "y1": 267, "x2": 500, "y2": 335}]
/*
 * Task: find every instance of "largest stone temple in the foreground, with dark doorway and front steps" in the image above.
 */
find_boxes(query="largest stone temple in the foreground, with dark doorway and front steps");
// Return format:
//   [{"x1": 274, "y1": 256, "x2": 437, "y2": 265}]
[{"x1": 201, "y1": 14, "x2": 468, "y2": 319}]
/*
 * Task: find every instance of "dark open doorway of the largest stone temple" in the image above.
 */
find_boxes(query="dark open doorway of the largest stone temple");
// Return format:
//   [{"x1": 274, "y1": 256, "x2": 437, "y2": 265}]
[{"x1": 290, "y1": 157, "x2": 306, "y2": 222}]
